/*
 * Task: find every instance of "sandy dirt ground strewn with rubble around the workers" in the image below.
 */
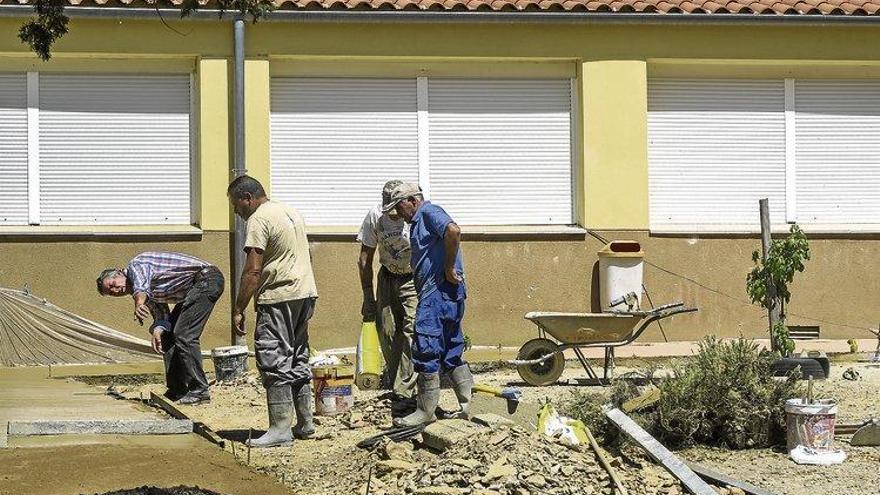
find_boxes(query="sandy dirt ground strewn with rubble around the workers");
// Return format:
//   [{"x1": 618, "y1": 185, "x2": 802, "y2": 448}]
[{"x1": 81, "y1": 361, "x2": 880, "y2": 495}]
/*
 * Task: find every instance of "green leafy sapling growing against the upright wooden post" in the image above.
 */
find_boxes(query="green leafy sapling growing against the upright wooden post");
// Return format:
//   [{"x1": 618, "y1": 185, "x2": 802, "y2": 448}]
[{"x1": 746, "y1": 225, "x2": 810, "y2": 356}]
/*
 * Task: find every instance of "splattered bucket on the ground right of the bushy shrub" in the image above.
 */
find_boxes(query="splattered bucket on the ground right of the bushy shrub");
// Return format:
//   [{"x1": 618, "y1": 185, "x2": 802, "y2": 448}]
[{"x1": 785, "y1": 399, "x2": 837, "y2": 452}]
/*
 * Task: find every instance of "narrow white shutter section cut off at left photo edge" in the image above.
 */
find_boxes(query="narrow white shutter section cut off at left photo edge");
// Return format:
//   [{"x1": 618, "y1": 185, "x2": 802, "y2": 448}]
[{"x1": 0, "y1": 74, "x2": 28, "y2": 225}]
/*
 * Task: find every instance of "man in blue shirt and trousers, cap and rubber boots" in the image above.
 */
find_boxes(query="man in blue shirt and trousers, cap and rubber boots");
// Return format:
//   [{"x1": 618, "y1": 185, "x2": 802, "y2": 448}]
[{"x1": 382, "y1": 183, "x2": 474, "y2": 426}]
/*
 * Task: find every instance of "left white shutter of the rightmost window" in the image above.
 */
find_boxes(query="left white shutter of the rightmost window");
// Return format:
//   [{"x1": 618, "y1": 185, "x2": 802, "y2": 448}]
[{"x1": 648, "y1": 79, "x2": 786, "y2": 231}]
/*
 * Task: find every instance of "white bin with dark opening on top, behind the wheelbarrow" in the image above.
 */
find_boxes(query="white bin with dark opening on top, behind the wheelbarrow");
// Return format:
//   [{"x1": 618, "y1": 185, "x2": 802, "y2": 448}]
[{"x1": 598, "y1": 241, "x2": 645, "y2": 312}]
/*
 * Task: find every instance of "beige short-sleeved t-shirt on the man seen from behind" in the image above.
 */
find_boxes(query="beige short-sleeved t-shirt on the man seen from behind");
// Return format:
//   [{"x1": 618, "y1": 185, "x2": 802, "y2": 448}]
[{"x1": 244, "y1": 201, "x2": 318, "y2": 304}]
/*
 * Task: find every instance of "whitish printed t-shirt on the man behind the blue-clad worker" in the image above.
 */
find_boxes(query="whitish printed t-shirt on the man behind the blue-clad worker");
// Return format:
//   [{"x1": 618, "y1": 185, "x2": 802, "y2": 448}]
[{"x1": 358, "y1": 206, "x2": 412, "y2": 275}]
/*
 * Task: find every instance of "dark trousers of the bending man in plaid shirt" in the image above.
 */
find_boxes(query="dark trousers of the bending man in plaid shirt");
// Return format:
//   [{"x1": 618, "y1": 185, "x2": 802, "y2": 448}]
[{"x1": 162, "y1": 267, "x2": 224, "y2": 396}]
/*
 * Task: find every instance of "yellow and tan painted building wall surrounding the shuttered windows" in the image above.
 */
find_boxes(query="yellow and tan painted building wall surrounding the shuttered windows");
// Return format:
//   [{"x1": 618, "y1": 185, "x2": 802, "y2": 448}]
[{"x1": 0, "y1": 18, "x2": 880, "y2": 347}]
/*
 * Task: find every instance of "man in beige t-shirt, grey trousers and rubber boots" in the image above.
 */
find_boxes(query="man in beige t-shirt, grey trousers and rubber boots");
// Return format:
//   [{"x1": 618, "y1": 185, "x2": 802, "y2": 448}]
[{"x1": 227, "y1": 175, "x2": 318, "y2": 447}]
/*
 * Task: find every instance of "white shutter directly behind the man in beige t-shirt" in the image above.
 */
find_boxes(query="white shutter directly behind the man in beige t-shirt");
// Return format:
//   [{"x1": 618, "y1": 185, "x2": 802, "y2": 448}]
[{"x1": 271, "y1": 78, "x2": 419, "y2": 226}]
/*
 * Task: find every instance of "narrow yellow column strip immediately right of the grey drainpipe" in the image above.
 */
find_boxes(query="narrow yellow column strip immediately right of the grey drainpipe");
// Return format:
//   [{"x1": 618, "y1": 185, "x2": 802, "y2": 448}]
[{"x1": 244, "y1": 59, "x2": 272, "y2": 197}]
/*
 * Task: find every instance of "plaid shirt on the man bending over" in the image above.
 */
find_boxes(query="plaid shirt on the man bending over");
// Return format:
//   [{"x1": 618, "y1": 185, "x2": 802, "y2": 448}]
[{"x1": 125, "y1": 251, "x2": 212, "y2": 332}]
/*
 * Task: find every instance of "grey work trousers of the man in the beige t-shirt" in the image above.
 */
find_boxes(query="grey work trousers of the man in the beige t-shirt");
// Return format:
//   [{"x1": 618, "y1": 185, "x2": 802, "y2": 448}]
[{"x1": 254, "y1": 297, "x2": 315, "y2": 388}]
